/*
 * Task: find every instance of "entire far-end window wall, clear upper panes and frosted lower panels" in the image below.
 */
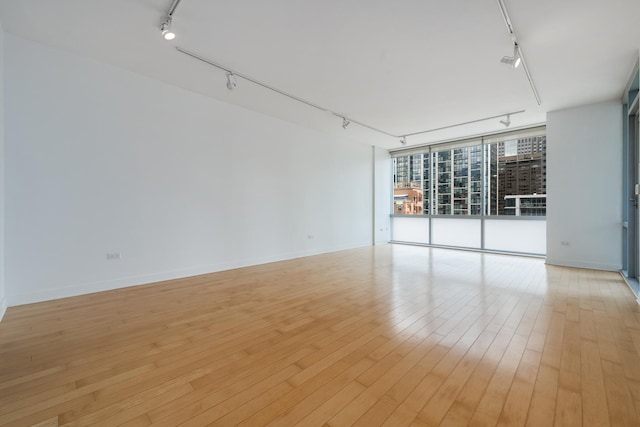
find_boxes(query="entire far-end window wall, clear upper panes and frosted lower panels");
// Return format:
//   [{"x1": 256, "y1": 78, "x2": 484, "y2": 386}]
[{"x1": 392, "y1": 127, "x2": 546, "y2": 255}]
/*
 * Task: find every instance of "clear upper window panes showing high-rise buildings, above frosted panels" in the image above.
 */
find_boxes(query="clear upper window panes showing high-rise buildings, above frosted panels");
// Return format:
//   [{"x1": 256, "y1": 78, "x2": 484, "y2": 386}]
[{"x1": 392, "y1": 129, "x2": 547, "y2": 217}]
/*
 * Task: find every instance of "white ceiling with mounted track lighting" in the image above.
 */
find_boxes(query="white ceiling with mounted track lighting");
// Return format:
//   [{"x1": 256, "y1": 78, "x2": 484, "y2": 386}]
[{"x1": 0, "y1": 0, "x2": 640, "y2": 148}]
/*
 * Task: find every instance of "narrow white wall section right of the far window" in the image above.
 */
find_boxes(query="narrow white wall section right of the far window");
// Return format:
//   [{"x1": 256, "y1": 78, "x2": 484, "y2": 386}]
[{"x1": 547, "y1": 101, "x2": 622, "y2": 270}]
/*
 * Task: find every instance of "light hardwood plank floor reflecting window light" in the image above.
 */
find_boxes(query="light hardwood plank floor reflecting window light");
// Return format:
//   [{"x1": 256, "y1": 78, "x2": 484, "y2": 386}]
[{"x1": 0, "y1": 245, "x2": 640, "y2": 426}]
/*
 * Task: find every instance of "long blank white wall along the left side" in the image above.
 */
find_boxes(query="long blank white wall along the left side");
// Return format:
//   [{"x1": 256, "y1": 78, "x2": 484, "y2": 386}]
[{"x1": 5, "y1": 34, "x2": 376, "y2": 305}]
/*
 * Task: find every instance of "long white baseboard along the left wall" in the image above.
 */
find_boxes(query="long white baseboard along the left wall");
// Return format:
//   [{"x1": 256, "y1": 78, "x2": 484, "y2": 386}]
[{"x1": 6, "y1": 242, "x2": 371, "y2": 306}]
